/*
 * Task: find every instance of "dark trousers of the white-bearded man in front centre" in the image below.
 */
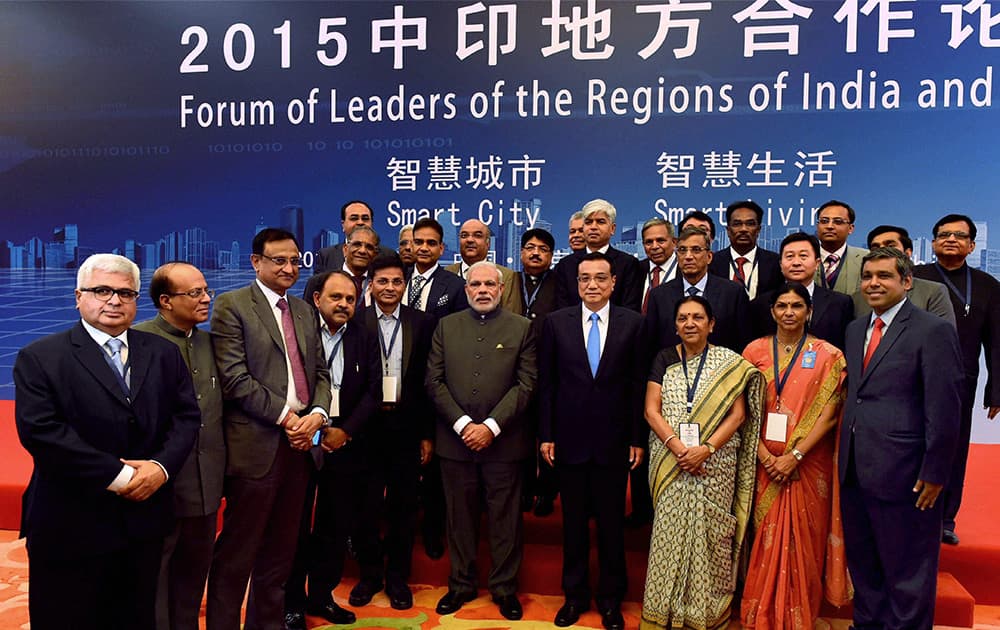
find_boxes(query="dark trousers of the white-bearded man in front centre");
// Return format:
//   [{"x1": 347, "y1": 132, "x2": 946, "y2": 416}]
[{"x1": 441, "y1": 458, "x2": 524, "y2": 596}]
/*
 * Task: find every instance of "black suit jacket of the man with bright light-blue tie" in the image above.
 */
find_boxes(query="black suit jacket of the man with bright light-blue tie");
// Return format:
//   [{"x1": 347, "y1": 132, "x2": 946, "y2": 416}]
[{"x1": 538, "y1": 305, "x2": 648, "y2": 465}]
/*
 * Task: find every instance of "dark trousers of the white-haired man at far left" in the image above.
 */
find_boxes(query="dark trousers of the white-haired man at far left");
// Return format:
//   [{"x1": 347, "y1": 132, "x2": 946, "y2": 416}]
[{"x1": 28, "y1": 540, "x2": 163, "y2": 630}]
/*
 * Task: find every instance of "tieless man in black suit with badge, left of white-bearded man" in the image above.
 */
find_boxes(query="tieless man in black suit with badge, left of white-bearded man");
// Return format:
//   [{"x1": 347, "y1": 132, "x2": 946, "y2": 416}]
[{"x1": 350, "y1": 255, "x2": 435, "y2": 610}]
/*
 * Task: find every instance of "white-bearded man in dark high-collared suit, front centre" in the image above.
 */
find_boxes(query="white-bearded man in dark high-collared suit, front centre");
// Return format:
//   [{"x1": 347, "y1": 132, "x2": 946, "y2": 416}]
[{"x1": 426, "y1": 261, "x2": 537, "y2": 619}]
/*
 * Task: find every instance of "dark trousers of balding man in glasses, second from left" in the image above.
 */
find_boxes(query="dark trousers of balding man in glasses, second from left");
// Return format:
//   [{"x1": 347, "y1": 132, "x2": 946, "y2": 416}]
[{"x1": 156, "y1": 512, "x2": 218, "y2": 630}]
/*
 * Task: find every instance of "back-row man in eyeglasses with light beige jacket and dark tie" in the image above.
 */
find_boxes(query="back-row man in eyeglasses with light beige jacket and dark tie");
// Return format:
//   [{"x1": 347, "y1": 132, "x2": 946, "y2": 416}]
[{"x1": 816, "y1": 199, "x2": 868, "y2": 297}]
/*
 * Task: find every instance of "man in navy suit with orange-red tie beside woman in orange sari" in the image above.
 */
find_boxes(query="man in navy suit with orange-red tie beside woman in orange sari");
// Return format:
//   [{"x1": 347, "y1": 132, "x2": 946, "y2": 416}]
[{"x1": 838, "y1": 248, "x2": 963, "y2": 630}]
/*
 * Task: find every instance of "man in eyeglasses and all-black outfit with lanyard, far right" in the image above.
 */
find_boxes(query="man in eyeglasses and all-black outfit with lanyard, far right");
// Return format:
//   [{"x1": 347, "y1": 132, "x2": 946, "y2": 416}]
[{"x1": 913, "y1": 214, "x2": 1000, "y2": 545}]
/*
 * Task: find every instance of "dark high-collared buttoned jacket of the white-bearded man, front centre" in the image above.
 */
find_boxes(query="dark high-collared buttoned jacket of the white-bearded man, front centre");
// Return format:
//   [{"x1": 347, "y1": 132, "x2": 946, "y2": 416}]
[{"x1": 425, "y1": 308, "x2": 537, "y2": 462}]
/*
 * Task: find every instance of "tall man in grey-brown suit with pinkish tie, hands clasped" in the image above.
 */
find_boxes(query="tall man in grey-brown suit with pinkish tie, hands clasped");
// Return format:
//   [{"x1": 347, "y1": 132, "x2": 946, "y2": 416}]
[{"x1": 206, "y1": 228, "x2": 331, "y2": 630}]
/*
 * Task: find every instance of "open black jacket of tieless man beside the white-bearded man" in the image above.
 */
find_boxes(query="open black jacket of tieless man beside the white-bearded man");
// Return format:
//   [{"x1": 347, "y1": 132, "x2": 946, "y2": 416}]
[{"x1": 364, "y1": 305, "x2": 436, "y2": 440}]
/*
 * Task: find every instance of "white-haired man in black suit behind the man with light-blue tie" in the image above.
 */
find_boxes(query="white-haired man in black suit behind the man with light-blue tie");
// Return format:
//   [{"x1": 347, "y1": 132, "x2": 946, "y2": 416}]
[{"x1": 555, "y1": 199, "x2": 642, "y2": 313}]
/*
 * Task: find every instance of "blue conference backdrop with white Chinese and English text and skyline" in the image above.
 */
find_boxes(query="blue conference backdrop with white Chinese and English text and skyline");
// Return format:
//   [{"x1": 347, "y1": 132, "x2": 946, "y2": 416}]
[{"x1": 0, "y1": 0, "x2": 1000, "y2": 441}]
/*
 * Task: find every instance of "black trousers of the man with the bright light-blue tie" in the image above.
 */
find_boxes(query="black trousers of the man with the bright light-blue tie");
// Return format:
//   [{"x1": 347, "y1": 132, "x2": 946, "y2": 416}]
[{"x1": 556, "y1": 462, "x2": 628, "y2": 609}]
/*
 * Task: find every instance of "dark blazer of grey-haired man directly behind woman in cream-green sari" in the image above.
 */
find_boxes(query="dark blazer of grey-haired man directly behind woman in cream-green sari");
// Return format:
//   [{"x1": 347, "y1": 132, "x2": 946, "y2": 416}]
[{"x1": 643, "y1": 274, "x2": 750, "y2": 358}]
